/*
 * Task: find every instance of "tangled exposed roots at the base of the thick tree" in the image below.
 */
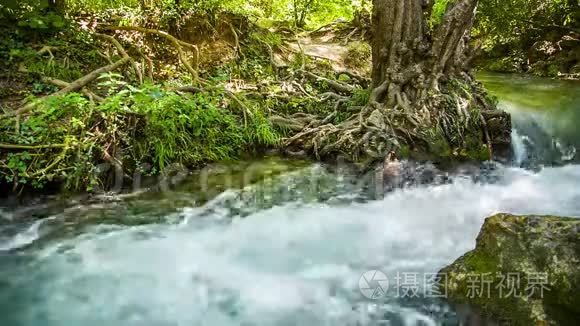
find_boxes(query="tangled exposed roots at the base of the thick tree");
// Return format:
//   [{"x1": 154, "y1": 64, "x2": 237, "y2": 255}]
[{"x1": 270, "y1": 72, "x2": 509, "y2": 161}]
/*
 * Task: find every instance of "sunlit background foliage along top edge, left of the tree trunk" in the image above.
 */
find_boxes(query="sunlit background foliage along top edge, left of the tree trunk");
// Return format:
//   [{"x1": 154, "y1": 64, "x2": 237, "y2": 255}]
[{"x1": 0, "y1": 0, "x2": 358, "y2": 33}]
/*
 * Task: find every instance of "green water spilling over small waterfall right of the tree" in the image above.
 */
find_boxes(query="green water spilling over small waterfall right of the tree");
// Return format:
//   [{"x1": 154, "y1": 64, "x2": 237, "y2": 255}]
[{"x1": 478, "y1": 73, "x2": 580, "y2": 166}]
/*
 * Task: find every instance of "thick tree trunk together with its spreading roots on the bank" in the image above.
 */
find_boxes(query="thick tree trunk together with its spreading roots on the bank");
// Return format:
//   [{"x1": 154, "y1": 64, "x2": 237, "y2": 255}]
[{"x1": 288, "y1": 0, "x2": 511, "y2": 160}]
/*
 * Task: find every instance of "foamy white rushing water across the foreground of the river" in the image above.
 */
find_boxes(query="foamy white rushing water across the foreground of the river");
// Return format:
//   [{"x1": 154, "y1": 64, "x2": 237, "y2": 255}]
[{"x1": 0, "y1": 162, "x2": 580, "y2": 325}]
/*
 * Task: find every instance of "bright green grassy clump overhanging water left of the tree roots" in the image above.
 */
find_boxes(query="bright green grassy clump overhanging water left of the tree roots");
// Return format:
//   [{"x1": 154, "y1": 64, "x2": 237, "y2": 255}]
[{"x1": 132, "y1": 89, "x2": 254, "y2": 169}]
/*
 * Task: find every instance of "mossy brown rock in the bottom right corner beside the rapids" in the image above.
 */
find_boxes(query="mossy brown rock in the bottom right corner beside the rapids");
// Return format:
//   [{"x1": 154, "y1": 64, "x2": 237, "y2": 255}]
[{"x1": 440, "y1": 214, "x2": 580, "y2": 325}]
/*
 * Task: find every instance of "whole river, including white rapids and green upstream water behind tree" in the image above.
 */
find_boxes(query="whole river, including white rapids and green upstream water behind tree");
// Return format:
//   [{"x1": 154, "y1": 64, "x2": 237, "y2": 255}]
[{"x1": 0, "y1": 74, "x2": 580, "y2": 326}]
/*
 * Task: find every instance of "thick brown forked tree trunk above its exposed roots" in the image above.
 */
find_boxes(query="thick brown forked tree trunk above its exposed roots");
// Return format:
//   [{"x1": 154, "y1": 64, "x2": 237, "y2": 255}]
[{"x1": 372, "y1": 0, "x2": 478, "y2": 105}]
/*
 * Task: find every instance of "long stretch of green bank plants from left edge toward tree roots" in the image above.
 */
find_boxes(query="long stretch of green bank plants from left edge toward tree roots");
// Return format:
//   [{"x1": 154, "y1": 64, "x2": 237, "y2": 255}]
[{"x1": 0, "y1": 82, "x2": 279, "y2": 191}]
